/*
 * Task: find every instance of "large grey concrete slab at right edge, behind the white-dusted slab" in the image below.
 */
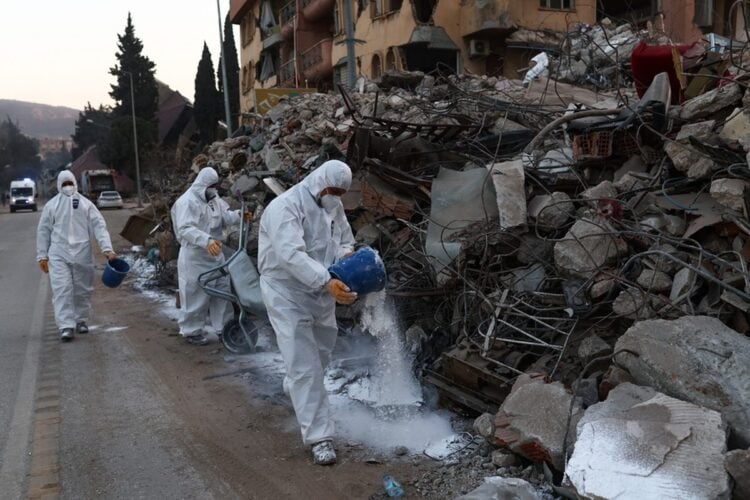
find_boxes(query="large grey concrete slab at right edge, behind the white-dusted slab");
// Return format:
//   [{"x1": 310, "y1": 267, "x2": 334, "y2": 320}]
[{"x1": 615, "y1": 316, "x2": 750, "y2": 447}]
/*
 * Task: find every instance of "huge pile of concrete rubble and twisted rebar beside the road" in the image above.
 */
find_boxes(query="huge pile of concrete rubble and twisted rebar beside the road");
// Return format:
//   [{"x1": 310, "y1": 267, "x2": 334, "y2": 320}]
[{"x1": 129, "y1": 25, "x2": 750, "y2": 498}]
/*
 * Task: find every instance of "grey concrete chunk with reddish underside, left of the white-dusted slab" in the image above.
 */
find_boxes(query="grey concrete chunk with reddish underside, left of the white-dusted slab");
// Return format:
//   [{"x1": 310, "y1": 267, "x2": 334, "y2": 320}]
[{"x1": 494, "y1": 374, "x2": 581, "y2": 470}]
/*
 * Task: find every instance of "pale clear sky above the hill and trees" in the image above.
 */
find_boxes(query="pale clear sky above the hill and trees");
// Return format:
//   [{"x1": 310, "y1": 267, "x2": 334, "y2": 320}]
[{"x1": 0, "y1": 0, "x2": 239, "y2": 109}]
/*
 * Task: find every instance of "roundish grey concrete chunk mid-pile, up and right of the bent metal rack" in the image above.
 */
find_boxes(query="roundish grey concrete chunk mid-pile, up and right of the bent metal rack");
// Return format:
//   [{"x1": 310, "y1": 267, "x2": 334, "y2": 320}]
[{"x1": 554, "y1": 217, "x2": 628, "y2": 277}]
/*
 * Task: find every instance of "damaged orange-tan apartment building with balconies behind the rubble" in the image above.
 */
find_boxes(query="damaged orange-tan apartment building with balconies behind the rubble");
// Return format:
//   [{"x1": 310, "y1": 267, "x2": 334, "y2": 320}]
[{"x1": 230, "y1": 0, "x2": 746, "y2": 111}]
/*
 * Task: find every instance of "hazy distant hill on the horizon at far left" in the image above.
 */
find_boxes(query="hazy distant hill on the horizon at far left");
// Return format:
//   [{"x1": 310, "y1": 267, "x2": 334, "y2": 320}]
[{"x1": 0, "y1": 99, "x2": 78, "y2": 139}]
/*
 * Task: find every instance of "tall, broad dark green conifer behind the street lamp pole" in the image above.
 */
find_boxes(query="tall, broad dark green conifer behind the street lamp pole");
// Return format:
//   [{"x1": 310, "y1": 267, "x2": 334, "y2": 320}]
[{"x1": 105, "y1": 13, "x2": 159, "y2": 175}]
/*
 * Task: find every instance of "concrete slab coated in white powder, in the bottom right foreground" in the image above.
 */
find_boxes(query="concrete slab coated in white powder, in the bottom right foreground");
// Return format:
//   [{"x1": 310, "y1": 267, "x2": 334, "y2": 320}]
[{"x1": 565, "y1": 383, "x2": 730, "y2": 500}]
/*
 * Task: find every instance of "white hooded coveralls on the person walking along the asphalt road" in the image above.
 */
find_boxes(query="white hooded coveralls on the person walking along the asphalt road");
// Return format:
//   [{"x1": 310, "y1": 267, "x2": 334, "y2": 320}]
[{"x1": 36, "y1": 170, "x2": 113, "y2": 330}]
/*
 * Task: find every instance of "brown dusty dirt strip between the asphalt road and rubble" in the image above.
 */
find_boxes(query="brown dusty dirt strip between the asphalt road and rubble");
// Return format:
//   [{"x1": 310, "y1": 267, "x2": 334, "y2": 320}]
[{"x1": 92, "y1": 205, "x2": 447, "y2": 499}]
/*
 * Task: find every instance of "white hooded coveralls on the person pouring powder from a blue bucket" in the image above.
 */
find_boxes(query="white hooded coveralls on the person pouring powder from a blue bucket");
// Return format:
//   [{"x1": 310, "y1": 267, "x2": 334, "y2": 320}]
[{"x1": 258, "y1": 160, "x2": 354, "y2": 445}]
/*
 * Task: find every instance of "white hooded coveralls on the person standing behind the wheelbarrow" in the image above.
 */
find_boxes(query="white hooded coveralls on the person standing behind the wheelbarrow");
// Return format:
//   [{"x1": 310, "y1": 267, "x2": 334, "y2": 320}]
[{"x1": 171, "y1": 167, "x2": 240, "y2": 337}]
